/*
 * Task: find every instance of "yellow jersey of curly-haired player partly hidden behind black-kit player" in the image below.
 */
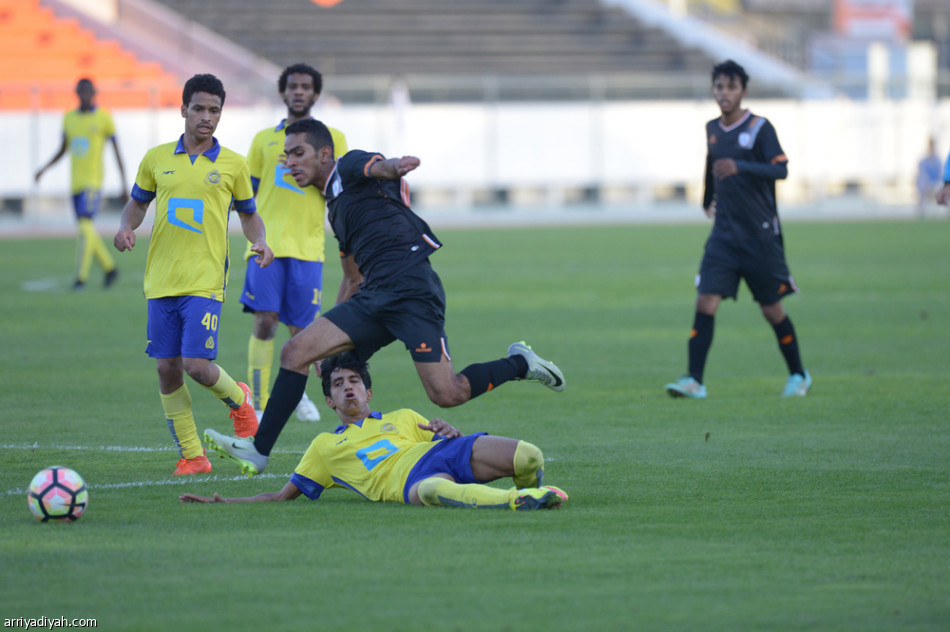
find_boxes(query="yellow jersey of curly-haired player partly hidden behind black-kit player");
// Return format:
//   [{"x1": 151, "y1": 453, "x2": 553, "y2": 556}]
[{"x1": 244, "y1": 121, "x2": 347, "y2": 261}]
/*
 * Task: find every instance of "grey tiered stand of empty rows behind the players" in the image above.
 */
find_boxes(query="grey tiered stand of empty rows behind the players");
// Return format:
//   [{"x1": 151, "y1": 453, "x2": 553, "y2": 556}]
[{"x1": 143, "y1": 0, "x2": 752, "y2": 102}]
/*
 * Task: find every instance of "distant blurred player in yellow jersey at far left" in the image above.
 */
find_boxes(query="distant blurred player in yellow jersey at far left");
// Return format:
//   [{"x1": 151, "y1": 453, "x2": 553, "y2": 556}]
[{"x1": 36, "y1": 79, "x2": 127, "y2": 290}]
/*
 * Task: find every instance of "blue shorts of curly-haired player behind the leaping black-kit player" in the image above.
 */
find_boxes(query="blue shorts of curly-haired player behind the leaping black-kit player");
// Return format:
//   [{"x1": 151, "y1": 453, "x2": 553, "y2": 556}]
[{"x1": 241, "y1": 255, "x2": 323, "y2": 329}]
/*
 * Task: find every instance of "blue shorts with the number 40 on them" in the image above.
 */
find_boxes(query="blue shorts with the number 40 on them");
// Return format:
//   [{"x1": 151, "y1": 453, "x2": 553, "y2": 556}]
[{"x1": 145, "y1": 296, "x2": 221, "y2": 360}]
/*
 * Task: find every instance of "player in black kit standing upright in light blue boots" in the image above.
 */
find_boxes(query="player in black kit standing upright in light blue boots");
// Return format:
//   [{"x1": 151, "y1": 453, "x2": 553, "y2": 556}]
[{"x1": 666, "y1": 60, "x2": 811, "y2": 399}]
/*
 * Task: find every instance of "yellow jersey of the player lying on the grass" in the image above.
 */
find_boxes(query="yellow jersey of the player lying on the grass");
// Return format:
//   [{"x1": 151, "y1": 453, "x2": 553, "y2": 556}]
[{"x1": 290, "y1": 408, "x2": 438, "y2": 503}]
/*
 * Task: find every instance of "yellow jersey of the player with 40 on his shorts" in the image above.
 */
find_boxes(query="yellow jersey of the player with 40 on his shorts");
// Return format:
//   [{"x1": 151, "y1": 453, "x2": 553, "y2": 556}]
[{"x1": 132, "y1": 139, "x2": 256, "y2": 301}]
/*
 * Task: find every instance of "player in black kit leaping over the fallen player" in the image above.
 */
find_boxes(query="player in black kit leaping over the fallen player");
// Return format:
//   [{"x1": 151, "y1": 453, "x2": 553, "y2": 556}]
[{"x1": 205, "y1": 119, "x2": 564, "y2": 475}]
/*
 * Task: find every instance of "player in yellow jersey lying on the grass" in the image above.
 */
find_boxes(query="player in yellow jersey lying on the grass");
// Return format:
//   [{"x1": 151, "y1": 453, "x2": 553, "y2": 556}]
[{"x1": 179, "y1": 352, "x2": 567, "y2": 510}]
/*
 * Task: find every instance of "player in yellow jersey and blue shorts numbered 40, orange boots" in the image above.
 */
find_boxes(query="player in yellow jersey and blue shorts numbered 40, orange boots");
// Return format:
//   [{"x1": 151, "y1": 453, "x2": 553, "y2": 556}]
[{"x1": 114, "y1": 75, "x2": 274, "y2": 476}]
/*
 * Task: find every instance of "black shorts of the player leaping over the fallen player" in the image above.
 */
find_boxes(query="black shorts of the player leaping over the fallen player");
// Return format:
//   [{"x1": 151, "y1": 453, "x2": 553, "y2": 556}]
[{"x1": 322, "y1": 262, "x2": 450, "y2": 362}]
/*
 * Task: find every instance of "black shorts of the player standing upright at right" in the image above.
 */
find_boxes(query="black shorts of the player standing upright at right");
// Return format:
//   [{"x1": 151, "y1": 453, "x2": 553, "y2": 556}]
[{"x1": 696, "y1": 237, "x2": 798, "y2": 305}]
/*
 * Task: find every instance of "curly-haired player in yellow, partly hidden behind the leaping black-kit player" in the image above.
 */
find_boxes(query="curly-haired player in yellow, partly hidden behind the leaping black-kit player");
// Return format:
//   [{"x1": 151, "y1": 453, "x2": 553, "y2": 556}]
[{"x1": 241, "y1": 64, "x2": 347, "y2": 421}]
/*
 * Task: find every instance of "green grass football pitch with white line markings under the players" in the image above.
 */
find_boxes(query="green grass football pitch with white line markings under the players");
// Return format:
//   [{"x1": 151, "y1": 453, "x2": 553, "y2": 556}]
[{"x1": 0, "y1": 221, "x2": 950, "y2": 632}]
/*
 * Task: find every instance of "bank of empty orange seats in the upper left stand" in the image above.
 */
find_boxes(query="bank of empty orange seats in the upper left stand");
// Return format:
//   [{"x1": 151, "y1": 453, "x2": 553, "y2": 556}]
[{"x1": 0, "y1": 0, "x2": 181, "y2": 110}]
